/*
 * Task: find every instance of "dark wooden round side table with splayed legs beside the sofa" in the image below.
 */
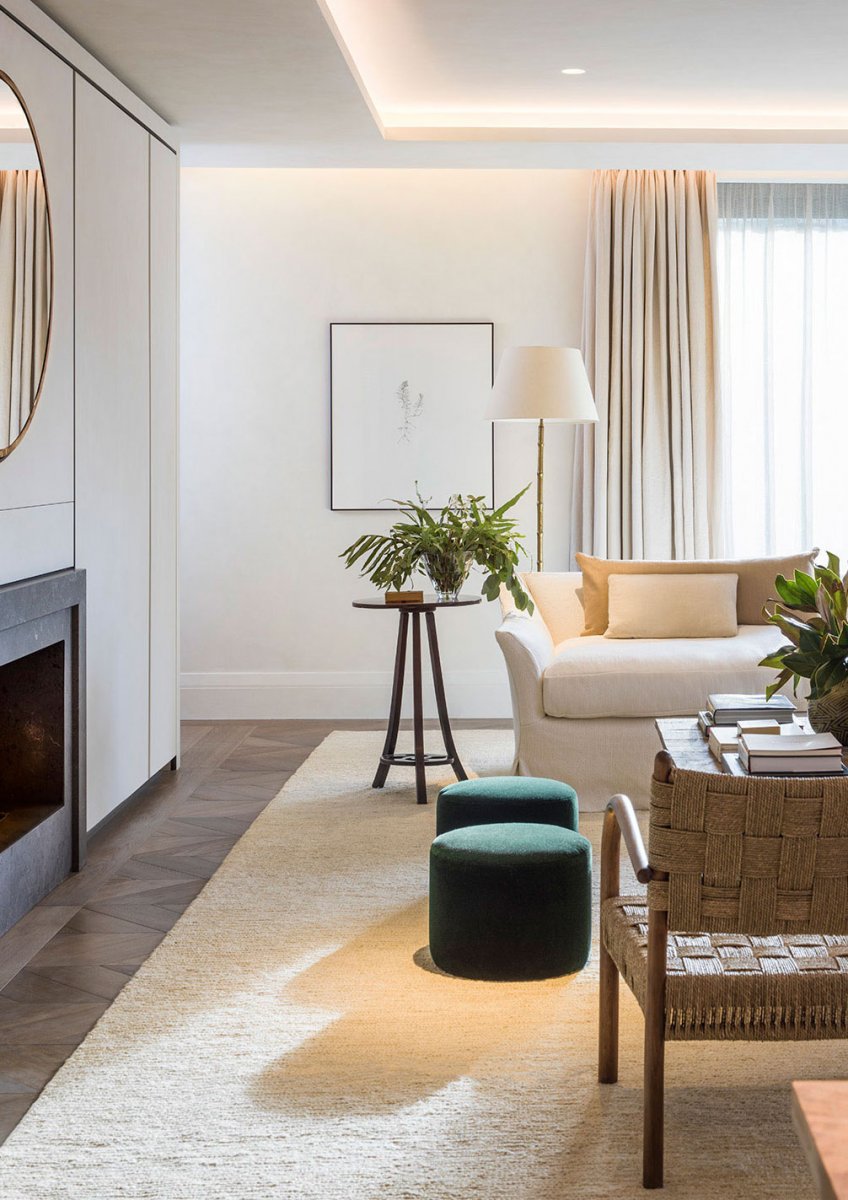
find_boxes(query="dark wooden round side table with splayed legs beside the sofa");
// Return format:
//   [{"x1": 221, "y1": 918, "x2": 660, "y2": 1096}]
[{"x1": 354, "y1": 595, "x2": 482, "y2": 804}]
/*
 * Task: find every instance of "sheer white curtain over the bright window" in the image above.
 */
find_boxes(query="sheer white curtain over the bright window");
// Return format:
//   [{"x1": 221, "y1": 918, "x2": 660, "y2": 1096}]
[{"x1": 717, "y1": 182, "x2": 848, "y2": 558}]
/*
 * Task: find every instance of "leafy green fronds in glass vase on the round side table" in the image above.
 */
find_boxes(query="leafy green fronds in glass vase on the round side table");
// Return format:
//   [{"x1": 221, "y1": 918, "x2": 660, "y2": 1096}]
[{"x1": 339, "y1": 484, "x2": 533, "y2": 613}]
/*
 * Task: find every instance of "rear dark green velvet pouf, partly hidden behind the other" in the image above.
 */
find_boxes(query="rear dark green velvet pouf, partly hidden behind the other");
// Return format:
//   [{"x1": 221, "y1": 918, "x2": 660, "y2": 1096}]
[{"x1": 435, "y1": 775, "x2": 577, "y2": 834}]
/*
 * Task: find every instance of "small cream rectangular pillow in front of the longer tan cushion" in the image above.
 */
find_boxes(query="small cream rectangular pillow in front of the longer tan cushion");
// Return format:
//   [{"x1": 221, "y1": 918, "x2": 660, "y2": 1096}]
[{"x1": 603, "y1": 574, "x2": 739, "y2": 637}]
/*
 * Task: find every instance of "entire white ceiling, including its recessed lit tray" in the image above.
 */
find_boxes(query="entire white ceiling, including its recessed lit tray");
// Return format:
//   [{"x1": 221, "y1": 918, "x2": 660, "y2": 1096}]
[{"x1": 24, "y1": 0, "x2": 848, "y2": 170}]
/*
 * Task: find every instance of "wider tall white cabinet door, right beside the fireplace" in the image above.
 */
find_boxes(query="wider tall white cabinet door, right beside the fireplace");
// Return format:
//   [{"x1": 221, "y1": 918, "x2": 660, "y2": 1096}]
[{"x1": 74, "y1": 77, "x2": 150, "y2": 827}]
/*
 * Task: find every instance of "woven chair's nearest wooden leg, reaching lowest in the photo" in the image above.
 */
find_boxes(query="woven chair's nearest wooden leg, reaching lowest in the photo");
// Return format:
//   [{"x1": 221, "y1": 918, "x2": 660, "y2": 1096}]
[{"x1": 642, "y1": 912, "x2": 668, "y2": 1188}]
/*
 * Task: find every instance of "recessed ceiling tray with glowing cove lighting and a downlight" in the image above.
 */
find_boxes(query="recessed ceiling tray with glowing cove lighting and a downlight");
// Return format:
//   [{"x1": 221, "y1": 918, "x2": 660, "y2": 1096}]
[{"x1": 319, "y1": 0, "x2": 848, "y2": 140}]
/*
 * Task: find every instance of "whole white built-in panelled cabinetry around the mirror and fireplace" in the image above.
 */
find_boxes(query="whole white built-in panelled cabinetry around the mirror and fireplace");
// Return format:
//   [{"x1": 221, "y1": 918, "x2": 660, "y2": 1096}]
[{"x1": 0, "y1": 0, "x2": 179, "y2": 827}]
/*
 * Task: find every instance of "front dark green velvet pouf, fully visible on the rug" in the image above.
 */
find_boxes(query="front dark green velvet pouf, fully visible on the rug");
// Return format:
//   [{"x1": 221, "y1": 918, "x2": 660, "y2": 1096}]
[{"x1": 429, "y1": 822, "x2": 591, "y2": 980}]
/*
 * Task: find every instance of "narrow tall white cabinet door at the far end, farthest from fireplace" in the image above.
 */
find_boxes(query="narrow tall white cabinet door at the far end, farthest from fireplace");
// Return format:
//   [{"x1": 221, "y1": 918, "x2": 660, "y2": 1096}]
[{"x1": 150, "y1": 138, "x2": 178, "y2": 775}]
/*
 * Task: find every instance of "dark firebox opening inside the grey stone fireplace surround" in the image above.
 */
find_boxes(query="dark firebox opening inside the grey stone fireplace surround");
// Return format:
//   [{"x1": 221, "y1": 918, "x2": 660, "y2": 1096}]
[{"x1": 0, "y1": 642, "x2": 66, "y2": 852}]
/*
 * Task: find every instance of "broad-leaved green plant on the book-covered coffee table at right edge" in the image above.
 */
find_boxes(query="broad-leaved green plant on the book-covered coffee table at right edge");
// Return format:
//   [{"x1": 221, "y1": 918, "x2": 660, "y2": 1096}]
[{"x1": 759, "y1": 553, "x2": 848, "y2": 701}]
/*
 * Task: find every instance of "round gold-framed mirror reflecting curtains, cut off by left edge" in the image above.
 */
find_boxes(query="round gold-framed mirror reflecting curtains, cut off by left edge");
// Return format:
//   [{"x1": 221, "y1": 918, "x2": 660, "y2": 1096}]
[{"x1": 0, "y1": 70, "x2": 53, "y2": 463}]
